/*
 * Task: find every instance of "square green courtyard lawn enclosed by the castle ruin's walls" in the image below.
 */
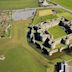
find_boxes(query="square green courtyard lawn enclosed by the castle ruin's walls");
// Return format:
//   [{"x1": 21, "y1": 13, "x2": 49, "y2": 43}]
[{"x1": 48, "y1": 25, "x2": 67, "y2": 39}]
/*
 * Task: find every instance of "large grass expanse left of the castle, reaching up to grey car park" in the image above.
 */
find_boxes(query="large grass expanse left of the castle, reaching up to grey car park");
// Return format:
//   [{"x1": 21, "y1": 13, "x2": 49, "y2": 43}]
[{"x1": 0, "y1": 21, "x2": 47, "y2": 72}]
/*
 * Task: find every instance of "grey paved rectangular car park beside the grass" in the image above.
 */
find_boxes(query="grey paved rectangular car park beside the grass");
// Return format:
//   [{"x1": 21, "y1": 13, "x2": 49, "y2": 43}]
[{"x1": 12, "y1": 9, "x2": 36, "y2": 21}]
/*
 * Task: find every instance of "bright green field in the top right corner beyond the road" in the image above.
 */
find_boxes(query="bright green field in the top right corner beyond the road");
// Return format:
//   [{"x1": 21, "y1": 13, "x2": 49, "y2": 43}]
[{"x1": 52, "y1": 0, "x2": 72, "y2": 10}]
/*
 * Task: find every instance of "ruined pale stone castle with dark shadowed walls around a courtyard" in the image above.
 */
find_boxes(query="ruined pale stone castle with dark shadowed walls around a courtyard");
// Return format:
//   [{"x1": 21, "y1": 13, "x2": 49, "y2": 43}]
[{"x1": 27, "y1": 17, "x2": 72, "y2": 56}]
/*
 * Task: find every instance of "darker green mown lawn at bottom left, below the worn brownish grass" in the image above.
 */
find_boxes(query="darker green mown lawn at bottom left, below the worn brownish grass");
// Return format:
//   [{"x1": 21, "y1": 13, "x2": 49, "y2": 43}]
[{"x1": 0, "y1": 44, "x2": 46, "y2": 72}]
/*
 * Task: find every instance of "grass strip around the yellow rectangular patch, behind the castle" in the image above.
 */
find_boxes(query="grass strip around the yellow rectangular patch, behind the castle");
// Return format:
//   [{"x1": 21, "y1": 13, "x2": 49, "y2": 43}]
[{"x1": 32, "y1": 8, "x2": 72, "y2": 24}]
